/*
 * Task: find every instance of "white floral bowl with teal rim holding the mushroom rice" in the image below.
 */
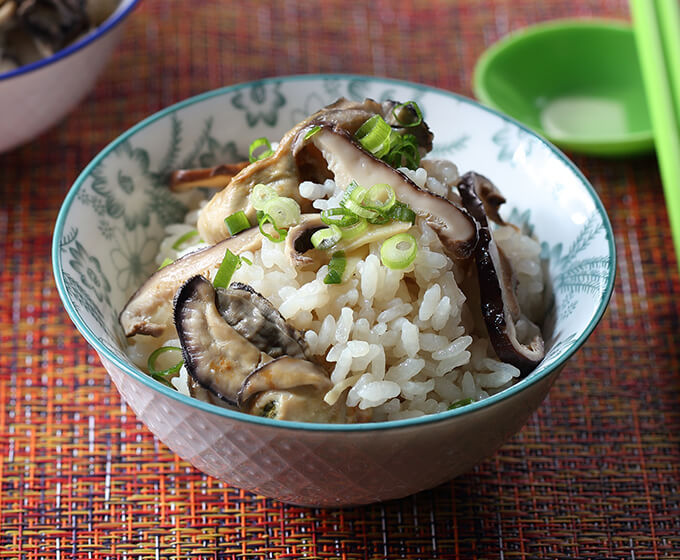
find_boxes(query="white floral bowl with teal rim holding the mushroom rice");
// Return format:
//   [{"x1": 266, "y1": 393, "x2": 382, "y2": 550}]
[{"x1": 53, "y1": 75, "x2": 615, "y2": 506}]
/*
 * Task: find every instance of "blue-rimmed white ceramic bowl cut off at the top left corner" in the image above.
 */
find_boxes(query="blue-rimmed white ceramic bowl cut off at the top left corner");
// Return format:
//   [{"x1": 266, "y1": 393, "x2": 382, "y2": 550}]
[{"x1": 0, "y1": 0, "x2": 139, "y2": 153}]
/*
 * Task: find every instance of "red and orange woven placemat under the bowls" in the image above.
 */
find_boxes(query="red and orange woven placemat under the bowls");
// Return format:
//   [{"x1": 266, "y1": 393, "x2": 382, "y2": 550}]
[{"x1": 0, "y1": 0, "x2": 680, "y2": 560}]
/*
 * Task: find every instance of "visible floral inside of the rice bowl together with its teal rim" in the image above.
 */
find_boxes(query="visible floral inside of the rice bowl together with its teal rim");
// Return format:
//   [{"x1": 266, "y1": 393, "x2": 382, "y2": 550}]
[{"x1": 53, "y1": 75, "x2": 615, "y2": 430}]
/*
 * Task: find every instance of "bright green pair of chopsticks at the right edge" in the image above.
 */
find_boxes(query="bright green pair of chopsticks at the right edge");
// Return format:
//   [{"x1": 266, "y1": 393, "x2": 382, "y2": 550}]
[{"x1": 630, "y1": 0, "x2": 680, "y2": 270}]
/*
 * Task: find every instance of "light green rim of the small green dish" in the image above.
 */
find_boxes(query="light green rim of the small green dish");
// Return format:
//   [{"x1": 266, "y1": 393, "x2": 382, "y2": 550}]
[{"x1": 472, "y1": 18, "x2": 654, "y2": 155}]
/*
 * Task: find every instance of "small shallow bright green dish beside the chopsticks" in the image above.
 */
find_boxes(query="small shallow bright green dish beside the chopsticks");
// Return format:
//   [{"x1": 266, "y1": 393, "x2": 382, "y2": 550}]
[{"x1": 473, "y1": 19, "x2": 654, "y2": 156}]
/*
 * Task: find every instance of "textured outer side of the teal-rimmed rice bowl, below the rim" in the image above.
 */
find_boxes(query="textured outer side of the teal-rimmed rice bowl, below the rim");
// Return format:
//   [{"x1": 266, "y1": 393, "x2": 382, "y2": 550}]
[{"x1": 102, "y1": 358, "x2": 559, "y2": 507}]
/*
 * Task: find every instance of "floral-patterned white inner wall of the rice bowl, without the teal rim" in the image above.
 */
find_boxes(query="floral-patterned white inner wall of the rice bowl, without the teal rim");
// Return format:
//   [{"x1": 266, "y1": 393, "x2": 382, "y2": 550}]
[{"x1": 57, "y1": 76, "x2": 613, "y2": 390}]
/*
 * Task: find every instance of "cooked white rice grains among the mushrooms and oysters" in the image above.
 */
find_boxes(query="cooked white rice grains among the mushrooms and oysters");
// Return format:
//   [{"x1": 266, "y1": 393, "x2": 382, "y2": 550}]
[{"x1": 125, "y1": 160, "x2": 545, "y2": 421}]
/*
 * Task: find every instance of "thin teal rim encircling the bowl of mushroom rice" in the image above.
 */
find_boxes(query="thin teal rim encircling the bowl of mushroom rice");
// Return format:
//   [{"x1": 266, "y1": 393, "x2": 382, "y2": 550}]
[{"x1": 52, "y1": 74, "x2": 616, "y2": 433}]
